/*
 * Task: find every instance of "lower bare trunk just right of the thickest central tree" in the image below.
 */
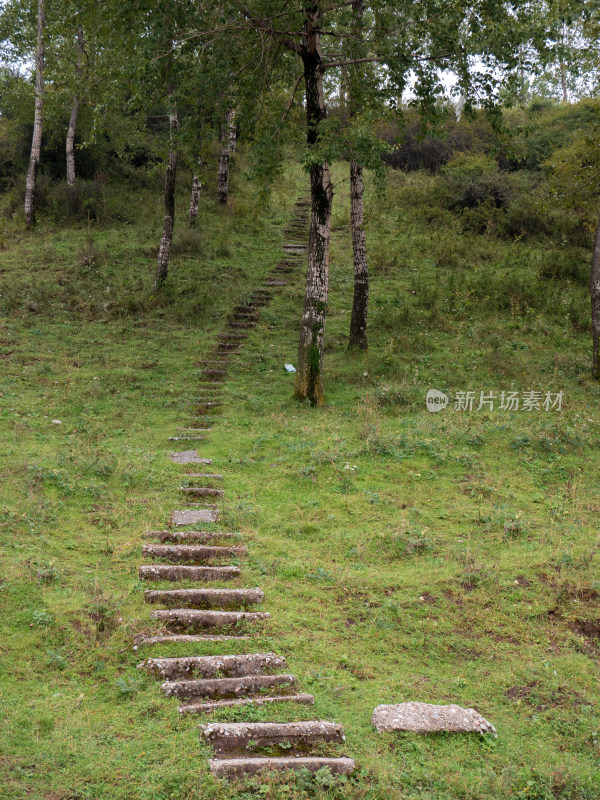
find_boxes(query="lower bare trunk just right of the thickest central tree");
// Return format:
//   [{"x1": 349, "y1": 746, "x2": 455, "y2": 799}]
[{"x1": 349, "y1": 160, "x2": 369, "y2": 350}]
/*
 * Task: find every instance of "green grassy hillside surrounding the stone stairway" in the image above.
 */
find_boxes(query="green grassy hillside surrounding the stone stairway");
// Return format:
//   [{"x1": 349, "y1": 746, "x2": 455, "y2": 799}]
[{"x1": 0, "y1": 156, "x2": 600, "y2": 800}]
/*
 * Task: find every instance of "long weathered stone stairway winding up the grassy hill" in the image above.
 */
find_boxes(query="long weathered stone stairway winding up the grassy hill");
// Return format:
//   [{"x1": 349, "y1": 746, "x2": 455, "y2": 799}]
[{"x1": 135, "y1": 200, "x2": 355, "y2": 778}]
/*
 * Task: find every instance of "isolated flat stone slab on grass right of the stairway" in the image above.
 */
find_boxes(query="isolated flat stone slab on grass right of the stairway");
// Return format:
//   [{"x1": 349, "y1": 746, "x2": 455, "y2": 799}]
[{"x1": 371, "y1": 702, "x2": 496, "y2": 734}]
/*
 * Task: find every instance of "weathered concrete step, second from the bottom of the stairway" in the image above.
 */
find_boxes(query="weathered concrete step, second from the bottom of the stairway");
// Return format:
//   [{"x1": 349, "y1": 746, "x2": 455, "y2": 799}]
[{"x1": 200, "y1": 720, "x2": 346, "y2": 756}]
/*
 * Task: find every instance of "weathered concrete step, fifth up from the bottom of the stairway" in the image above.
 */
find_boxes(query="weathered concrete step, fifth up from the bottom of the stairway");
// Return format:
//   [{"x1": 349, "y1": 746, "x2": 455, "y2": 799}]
[{"x1": 138, "y1": 653, "x2": 286, "y2": 679}]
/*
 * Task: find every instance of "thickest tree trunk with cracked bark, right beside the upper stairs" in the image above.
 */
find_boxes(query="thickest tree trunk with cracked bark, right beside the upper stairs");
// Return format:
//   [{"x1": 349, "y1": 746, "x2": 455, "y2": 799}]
[{"x1": 294, "y1": 3, "x2": 333, "y2": 405}]
